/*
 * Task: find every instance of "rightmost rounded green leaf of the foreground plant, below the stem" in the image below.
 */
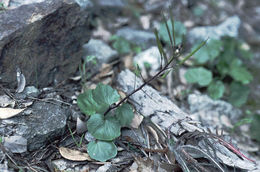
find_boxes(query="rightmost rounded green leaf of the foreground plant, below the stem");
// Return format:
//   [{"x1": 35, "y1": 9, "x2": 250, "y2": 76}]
[{"x1": 115, "y1": 103, "x2": 134, "y2": 127}]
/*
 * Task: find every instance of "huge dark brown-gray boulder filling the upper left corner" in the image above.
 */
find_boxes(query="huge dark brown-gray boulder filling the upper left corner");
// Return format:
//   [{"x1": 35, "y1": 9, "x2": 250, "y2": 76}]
[{"x1": 0, "y1": 0, "x2": 90, "y2": 87}]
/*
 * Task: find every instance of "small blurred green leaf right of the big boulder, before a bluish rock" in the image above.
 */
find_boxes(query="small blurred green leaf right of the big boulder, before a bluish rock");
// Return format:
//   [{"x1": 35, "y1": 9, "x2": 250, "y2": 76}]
[{"x1": 110, "y1": 35, "x2": 131, "y2": 54}]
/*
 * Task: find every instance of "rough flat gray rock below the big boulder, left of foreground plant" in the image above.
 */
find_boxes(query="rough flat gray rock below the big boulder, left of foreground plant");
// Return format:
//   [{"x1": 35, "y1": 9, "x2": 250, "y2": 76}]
[{"x1": 0, "y1": 102, "x2": 69, "y2": 151}]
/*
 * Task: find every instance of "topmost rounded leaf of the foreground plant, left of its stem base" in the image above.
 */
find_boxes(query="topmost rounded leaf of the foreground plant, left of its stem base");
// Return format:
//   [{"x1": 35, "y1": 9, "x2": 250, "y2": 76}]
[{"x1": 92, "y1": 84, "x2": 120, "y2": 114}]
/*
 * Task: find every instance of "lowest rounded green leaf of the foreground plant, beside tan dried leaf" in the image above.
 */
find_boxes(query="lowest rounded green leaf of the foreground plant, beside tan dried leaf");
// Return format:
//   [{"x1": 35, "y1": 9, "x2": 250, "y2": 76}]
[{"x1": 87, "y1": 140, "x2": 117, "y2": 162}]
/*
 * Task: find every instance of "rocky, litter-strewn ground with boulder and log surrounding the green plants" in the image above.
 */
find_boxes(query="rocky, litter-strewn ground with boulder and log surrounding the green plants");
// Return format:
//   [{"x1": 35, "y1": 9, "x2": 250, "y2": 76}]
[{"x1": 0, "y1": 0, "x2": 260, "y2": 172}]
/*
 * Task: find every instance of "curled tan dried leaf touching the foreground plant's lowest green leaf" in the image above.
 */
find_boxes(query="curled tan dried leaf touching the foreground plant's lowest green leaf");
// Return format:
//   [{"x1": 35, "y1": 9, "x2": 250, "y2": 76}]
[{"x1": 59, "y1": 147, "x2": 92, "y2": 161}]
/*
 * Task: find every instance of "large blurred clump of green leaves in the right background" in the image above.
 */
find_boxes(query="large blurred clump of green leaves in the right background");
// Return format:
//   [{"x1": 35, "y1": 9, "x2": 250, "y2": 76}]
[{"x1": 185, "y1": 37, "x2": 253, "y2": 107}]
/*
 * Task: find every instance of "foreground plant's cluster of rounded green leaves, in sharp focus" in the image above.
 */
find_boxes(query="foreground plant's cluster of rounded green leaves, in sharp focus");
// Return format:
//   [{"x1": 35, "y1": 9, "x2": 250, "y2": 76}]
[{"x1": 77, "y1": 84, "x2": 134, "y2": 161}]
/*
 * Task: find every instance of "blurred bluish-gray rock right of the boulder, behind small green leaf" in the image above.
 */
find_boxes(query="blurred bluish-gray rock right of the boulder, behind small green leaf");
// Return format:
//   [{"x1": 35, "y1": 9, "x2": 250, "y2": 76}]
[{"x1": 116, "y1": 27, "x2": 156, "y2": 49}]
